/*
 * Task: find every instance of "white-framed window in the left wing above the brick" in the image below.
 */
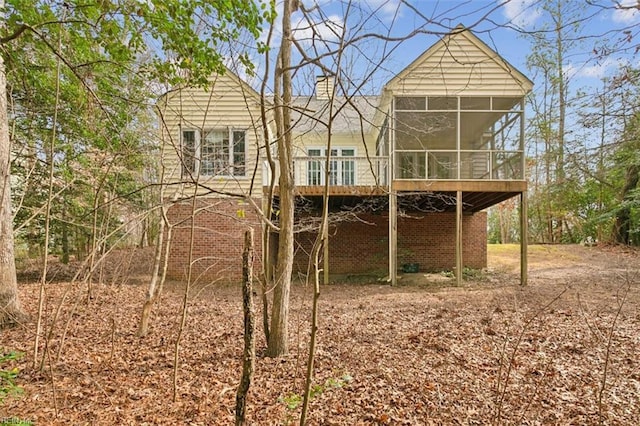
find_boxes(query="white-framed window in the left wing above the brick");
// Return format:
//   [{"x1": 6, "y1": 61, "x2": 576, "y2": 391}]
[{"x1": 181, "y1": 128, "x2": 247, "y2": 177}]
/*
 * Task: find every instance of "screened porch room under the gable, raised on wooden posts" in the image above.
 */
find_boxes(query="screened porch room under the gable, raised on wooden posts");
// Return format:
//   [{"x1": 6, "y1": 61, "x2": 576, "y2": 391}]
[{"x1": 392, "y1": 96, "x2": 524, "y2": 180}]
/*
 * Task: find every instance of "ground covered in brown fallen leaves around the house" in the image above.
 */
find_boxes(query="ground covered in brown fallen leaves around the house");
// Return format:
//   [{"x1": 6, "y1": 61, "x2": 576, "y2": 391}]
[{"x1": 0, "y1": 245, "x2": 640, "y2": 425}]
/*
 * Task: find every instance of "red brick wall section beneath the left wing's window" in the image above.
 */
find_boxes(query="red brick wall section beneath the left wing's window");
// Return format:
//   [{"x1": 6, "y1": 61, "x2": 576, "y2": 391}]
[{"x1": 167, "y1": 198, "x2": 262, "y2": 282}]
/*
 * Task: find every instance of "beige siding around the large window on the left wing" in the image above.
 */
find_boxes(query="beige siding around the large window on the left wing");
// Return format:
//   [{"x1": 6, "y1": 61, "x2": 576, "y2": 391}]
[{"x1": 158, "y1": 75, "x2": 264, "y2": 195}]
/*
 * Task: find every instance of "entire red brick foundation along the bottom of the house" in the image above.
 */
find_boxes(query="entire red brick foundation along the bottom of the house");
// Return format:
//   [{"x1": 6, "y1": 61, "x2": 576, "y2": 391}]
[{"x1": 168, "y1": 199, "x2": 487, "y2": 282}]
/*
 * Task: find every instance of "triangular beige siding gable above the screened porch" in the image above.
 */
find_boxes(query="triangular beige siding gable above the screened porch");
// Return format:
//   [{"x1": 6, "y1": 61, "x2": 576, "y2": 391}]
[{"x1": 388, "y1": 31, "x2": 530, "y2": 96}]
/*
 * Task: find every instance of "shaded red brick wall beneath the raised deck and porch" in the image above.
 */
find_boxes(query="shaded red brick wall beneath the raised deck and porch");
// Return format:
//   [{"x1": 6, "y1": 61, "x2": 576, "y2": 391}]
[{"x1": 295, "y1": 212, "x2": 487, "y2": 274}]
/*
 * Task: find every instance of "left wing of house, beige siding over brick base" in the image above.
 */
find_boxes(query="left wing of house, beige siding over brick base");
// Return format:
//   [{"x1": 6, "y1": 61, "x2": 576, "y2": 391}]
[{"x1": 158, "y1": 71, "x2": 265, "y2": 281}]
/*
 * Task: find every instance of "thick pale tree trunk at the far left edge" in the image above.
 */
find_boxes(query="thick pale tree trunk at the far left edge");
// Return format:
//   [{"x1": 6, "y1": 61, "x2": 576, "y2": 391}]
[{"x1": 0, "y1": 5, "x2": 25, "y2": 328}]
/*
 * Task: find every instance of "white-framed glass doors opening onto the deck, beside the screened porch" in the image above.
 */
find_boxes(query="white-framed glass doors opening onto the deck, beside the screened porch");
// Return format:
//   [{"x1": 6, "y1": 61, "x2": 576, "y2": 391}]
[{"x1": 307, "y1": 148, "x2": 356, "y2": 186}]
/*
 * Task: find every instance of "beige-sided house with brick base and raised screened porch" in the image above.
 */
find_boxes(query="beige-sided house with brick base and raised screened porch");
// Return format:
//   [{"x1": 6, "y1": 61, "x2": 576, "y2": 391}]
[{"x1": 161, "y1": 26, "x2": 532, "y2": 282}]
